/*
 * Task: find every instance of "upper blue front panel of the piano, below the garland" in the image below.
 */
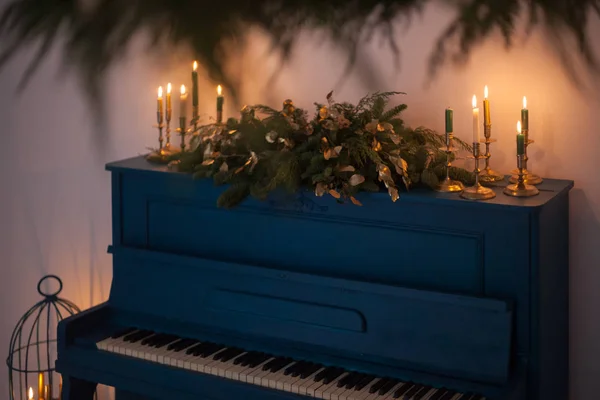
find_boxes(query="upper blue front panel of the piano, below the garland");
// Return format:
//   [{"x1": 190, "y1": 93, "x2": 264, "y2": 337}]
[{"x1": 113, "y1": 172, "x2": 530, "y2": 354}]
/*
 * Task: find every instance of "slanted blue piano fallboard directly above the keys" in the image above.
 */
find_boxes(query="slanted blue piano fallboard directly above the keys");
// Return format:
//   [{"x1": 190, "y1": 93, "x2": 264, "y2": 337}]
[{"x1": 109, "y1": 247, "x2": 512, "y2": 383}]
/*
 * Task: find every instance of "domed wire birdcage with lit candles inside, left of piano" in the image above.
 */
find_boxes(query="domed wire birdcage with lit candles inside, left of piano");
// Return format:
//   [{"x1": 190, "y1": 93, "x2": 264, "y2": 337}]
[{"x1": 6, "y1": 275, "x2": 81, "y2": 400}]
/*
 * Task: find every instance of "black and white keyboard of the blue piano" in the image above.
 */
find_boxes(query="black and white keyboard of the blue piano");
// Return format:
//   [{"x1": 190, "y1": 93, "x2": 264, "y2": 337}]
[{"x1": 97, "y1": 328, "x2": 485, "y2": 400}]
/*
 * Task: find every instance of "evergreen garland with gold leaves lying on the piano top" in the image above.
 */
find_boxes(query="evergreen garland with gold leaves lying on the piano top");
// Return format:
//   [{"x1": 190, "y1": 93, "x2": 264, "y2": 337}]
[{"x1": 170, "y1": 92, "x2": 473, "y2": 208}]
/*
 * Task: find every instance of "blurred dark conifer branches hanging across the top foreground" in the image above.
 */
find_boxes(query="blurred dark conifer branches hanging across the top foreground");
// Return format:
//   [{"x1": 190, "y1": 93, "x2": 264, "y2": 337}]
[{"x1": 0, "y1": 0, "x2": 600, "y2": 100}]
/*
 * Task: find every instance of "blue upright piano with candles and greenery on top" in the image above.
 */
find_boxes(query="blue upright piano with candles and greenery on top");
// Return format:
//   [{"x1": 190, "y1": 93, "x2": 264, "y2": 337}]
[{"x1": 56, "y1": 157, "x2": 573, "y2": 400}]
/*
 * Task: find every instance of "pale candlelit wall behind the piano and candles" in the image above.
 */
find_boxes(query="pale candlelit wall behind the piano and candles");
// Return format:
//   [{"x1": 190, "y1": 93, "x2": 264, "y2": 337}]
[{"x1": 0, "y1": 3, "x2": 600, "y2": 400}]
